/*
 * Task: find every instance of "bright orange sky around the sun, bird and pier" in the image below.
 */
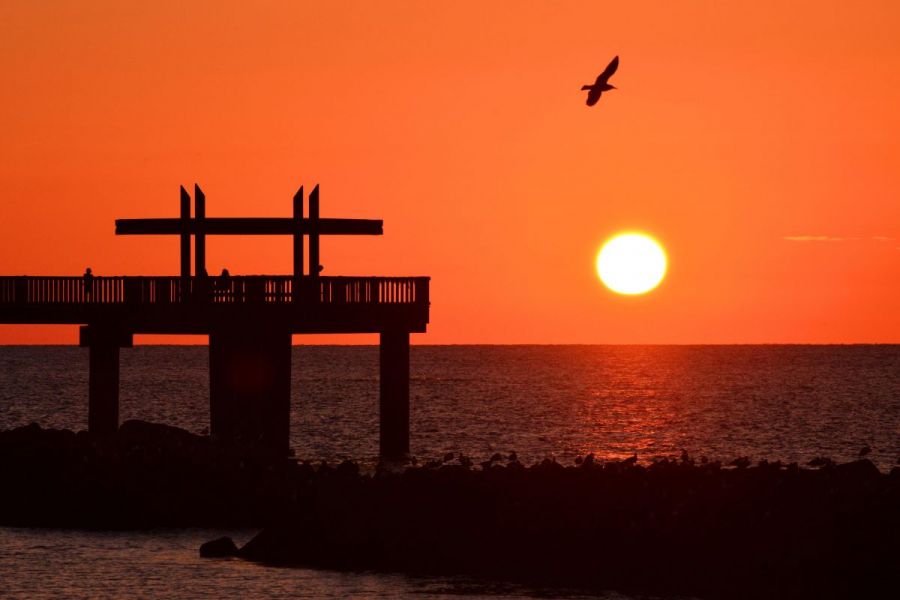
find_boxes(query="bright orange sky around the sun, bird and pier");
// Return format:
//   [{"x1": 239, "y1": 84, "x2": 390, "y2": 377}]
[{"x1": 0, "y1": 0, "x2": 900, "y2": 344}]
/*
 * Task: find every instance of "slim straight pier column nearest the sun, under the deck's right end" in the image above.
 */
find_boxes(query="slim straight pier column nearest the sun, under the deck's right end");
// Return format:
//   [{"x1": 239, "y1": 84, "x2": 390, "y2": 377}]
[{"x1": 379, "y1": 331, "x2": 409, "y2": 460}]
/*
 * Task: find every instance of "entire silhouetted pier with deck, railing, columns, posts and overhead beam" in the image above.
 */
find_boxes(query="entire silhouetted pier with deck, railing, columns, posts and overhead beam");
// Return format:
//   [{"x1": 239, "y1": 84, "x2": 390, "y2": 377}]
[{"x1": 0, "y1": 186, "x2": 429, "y2": 458}]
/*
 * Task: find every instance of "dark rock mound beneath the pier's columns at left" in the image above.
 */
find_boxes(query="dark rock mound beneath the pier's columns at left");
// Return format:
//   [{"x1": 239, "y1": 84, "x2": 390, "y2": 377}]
[{"x1": 0, "y1": 421, "x2": 302, "y2": 529}]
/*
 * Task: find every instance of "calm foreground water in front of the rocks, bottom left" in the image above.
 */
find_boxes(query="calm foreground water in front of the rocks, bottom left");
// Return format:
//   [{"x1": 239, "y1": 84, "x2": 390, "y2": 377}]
[{"x1": 0, "y1": 528, "x2": 648, "y2": 600}]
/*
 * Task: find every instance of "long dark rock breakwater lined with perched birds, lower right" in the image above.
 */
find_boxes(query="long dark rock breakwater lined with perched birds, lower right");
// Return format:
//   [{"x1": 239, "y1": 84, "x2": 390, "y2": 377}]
[{"x1": 225, "y1": 457, "x2": 900, "y2": 598}]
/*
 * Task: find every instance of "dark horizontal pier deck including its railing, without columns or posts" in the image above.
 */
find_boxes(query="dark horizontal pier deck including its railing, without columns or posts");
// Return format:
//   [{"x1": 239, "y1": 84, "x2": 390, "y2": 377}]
[{"x1": 0, "y1": 275, "x2": 429, "y2": 334}]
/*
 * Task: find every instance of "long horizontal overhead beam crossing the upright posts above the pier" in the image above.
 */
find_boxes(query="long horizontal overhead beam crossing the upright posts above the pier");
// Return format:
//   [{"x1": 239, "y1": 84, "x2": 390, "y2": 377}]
[{"x1": 116, "y1": 216, "x2": 384, "y2": 236}]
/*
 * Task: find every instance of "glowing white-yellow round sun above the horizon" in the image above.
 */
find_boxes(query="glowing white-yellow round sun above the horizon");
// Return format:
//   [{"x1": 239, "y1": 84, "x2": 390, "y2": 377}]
[{"x1": 597, "y1": 232, "x2": 668, "y2": 296}]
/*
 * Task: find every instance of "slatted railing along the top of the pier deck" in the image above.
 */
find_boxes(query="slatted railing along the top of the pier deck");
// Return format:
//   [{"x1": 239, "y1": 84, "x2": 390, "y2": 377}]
[{"x1": 0, "y1": 275, "x2": 429, "y2": 306}]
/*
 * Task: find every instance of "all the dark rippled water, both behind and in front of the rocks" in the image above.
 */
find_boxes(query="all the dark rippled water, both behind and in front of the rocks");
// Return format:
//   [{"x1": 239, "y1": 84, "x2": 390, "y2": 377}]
[{"x1": 0, "y1": 345, "x2": 900, "y2": 600}]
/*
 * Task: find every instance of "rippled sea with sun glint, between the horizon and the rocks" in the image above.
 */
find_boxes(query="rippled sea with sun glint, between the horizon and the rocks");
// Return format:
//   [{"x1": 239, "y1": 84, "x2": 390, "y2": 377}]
[{"x1": 0, "y1": 345, "x2": 900, "y2": 471}]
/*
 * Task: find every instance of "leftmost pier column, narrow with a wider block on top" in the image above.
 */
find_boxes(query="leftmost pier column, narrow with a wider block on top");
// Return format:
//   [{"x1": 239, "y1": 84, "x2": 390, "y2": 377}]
[{"x1": 79, "y1": 325, "x2": 132, "y2": 435}]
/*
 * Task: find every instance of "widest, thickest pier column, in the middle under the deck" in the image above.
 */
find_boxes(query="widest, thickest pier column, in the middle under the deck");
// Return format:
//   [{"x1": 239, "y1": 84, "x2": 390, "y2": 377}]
[{"x1": 209, "y1": 327, "x2": 291, "y2": 455}]
